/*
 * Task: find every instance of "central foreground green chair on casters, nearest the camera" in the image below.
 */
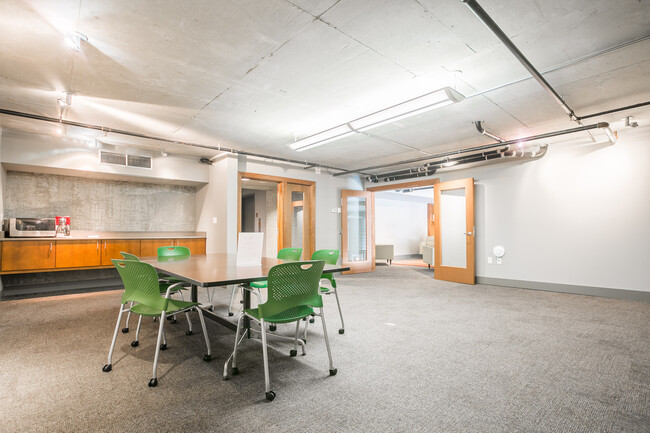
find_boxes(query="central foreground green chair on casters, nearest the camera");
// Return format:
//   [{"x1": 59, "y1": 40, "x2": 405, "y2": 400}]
[{"x1": 224, "y1": 260, "x2": 337, "y2": 401}]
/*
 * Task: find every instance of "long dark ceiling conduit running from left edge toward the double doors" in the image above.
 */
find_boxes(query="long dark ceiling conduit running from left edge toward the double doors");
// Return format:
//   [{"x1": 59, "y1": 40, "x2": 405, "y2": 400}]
[{"x1": 0, "y1": 108, "x2": 356, "y2": 175}]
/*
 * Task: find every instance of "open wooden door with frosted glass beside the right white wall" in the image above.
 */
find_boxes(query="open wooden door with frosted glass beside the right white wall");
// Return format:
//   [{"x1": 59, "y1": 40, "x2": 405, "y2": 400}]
[{"x1": 433, "y1": 178, "x2": 476, "y2": 284}]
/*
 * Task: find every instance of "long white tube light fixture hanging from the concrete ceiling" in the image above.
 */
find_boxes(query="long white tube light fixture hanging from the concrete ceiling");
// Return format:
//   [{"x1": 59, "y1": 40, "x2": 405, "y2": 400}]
[{"x1": 289, "y1": 87, "x2": 465, "y2": 152}]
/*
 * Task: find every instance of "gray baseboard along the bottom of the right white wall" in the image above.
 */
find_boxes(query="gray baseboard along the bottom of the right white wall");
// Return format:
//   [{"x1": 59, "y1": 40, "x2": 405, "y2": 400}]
[{"x1": 476, "y1": 277, "x2": 650, "y2": 302}]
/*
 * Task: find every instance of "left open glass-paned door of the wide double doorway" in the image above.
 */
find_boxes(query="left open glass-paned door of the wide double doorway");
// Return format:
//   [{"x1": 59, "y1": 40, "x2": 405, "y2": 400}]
[{"x1": 341, "y1": 189, "x2": 375, "y2": 274}]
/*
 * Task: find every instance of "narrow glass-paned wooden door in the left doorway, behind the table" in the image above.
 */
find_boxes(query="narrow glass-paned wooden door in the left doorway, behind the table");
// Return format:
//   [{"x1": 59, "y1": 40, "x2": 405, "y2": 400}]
[{"x1": 278, "y1": 183, "x2": 314, "y2": 258}]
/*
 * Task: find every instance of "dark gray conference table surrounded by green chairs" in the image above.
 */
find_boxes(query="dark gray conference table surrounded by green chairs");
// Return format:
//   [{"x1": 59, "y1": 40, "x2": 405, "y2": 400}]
[{"x1": 141, "y1": 254, "x2": 350, "y2": 330}]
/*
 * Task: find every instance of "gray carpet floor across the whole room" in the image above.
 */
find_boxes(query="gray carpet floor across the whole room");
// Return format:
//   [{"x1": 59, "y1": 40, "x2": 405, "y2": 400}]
[{"x1": 0, "y1": 266, "x2": 650, "y2": 432}]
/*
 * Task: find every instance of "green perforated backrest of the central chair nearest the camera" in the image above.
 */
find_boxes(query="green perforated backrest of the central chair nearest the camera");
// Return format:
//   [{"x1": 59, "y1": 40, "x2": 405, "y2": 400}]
[{"x1": 258, "y1": 260, "x2": 325, "y2": 318}]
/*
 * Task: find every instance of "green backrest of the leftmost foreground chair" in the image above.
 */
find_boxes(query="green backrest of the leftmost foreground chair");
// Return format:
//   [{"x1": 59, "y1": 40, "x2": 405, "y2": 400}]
[{"x1": 111, "y1": 259, "x2": 169, "y2": 310}]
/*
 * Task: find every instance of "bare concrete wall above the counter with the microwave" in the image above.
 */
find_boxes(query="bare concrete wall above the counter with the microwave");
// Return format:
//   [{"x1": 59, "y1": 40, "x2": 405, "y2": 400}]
[{"x1": 4, "y1": 170, "x2": 196, "y2": 231}]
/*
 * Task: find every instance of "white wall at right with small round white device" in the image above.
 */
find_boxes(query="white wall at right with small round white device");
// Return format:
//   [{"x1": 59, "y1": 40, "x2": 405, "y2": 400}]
[{"x1": 426, "y1": 128, "x2": 650, "y2": 292}]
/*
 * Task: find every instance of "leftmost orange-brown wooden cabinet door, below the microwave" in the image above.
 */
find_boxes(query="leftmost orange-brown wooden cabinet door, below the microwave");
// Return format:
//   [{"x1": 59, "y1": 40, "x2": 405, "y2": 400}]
[{"x1": 2, "y1": 240, "x2": 56, "y2": 271}]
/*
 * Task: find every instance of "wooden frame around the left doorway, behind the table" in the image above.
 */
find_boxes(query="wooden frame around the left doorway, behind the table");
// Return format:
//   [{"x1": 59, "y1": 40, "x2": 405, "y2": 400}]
[{"x1": 237, "y1": 171, "x2": 316, "y2": 258}]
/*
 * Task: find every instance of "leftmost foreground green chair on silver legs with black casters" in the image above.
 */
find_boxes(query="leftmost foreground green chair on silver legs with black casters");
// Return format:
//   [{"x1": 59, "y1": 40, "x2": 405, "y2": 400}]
[{"x1": 102, "y1": 259, "x2": 212, "y2": 387}]
